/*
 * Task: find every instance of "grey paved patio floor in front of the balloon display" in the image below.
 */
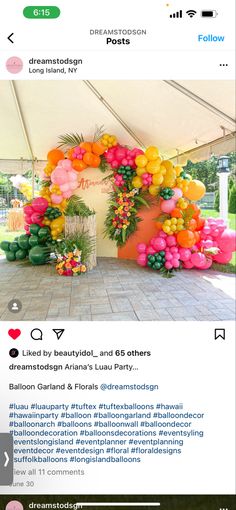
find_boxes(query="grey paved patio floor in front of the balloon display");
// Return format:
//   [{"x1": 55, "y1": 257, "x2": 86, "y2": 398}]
[{"x1": 0, "y1": 258, "x2": 235, "y2": 321}]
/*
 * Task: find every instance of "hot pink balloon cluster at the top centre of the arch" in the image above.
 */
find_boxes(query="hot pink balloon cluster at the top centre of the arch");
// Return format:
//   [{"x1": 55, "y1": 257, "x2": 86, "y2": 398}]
[{"x1": 104, "y1": 145, "x2": 143, "y2": 169}]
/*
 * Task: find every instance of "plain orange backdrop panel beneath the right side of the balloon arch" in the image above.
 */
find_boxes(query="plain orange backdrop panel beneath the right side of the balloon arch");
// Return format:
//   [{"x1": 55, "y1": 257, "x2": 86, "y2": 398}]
[{"x1": 118, "y1": 206, "x2": 160, "y2": 260}]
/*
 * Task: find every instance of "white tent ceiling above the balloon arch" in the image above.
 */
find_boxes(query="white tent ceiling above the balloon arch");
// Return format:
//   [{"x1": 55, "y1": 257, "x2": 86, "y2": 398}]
[{"x1": 0, "y1": 80, "x2": 235, "y2": 173}]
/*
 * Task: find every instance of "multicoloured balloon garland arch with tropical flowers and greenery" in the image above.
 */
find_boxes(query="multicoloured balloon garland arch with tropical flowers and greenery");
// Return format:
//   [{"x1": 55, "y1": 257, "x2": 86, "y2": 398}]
[{"x1": 2, "y1": 130, "x2": 235, "y2": 274}]
